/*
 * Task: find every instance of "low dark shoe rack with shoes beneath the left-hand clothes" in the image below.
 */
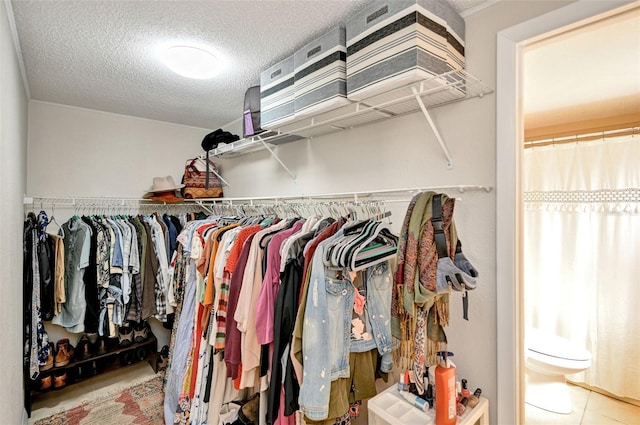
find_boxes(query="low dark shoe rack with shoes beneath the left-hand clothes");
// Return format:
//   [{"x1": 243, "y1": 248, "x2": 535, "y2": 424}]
[{"x1": 25, "y1": 333, "x2": 158, "y2": 417}]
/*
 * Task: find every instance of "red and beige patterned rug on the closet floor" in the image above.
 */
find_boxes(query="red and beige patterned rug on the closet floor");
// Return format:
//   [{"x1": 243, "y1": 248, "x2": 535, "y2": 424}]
[{"x1": 35, "y1": 375, "x2": 164, "y2": 425}]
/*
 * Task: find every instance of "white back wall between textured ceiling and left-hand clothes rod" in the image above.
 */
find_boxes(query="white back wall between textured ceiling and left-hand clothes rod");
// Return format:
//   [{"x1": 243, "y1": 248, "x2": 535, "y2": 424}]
[{"x1": 27, "y1": 100, "x2": 210, "y2": 198}]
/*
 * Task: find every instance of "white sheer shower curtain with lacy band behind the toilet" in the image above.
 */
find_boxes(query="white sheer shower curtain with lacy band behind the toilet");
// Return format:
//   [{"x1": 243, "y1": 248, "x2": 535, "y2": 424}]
[{"x1": 524, "y1": 134, "x2": 640, "y2": 400}]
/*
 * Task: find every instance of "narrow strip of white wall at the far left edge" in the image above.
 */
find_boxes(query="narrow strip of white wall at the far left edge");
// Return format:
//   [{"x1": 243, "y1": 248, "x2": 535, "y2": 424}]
[{"x1": 0, "y1": 5, "x2": 27, "y2": 424}]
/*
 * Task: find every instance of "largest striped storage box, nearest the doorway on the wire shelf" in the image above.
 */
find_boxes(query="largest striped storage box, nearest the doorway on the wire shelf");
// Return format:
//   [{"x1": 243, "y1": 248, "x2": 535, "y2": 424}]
[{"x1": 346, "y1": 0, "x2": 465, "y2": 100}]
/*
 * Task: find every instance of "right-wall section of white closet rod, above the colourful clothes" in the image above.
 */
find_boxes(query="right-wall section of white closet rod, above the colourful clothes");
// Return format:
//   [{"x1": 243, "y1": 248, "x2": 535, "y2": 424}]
[{"x1": 187, "y1": 185, "x2": 493, "y2": 204}]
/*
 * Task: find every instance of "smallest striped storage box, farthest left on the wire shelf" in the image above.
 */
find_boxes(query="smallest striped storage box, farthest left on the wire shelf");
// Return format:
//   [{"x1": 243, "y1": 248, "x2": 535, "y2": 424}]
[{"x1": 260, "y1": 56, "x2": 295, "y2": 129}]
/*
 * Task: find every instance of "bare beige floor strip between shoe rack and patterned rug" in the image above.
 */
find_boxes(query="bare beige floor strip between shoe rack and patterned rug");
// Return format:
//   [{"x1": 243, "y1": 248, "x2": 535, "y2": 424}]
[{"x1": 28, "y1": 362, "x2": 154, "y2": 425}]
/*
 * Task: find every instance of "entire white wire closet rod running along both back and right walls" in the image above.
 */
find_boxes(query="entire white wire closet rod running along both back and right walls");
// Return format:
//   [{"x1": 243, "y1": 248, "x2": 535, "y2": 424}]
[{"x1": 24, "y1": 185, "x2": 493, "y2": 206}]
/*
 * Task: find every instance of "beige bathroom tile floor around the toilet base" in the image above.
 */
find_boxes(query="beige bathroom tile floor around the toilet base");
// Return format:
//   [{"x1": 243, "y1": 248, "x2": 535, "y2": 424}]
[{"x1": 524, "y1": 384, "x2": 640, "y2": 425}]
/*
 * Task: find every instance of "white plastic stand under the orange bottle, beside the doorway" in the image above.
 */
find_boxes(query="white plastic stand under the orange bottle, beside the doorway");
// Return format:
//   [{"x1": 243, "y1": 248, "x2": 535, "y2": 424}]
[{"x1": 367, "y1": 386, "x2": 489, "y2": 425}]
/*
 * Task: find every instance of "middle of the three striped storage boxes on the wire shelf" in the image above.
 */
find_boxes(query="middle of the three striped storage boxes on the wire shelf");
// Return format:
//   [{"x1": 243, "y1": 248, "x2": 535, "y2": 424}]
[{"x1": 293, "y1": 27, "x2": 349, "y2": 118}]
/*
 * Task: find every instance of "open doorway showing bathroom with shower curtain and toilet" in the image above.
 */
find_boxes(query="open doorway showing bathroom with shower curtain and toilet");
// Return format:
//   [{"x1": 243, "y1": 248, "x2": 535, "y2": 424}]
[{"x1": 521, "y1": 5, "x2": 640, "y2": 425}]
